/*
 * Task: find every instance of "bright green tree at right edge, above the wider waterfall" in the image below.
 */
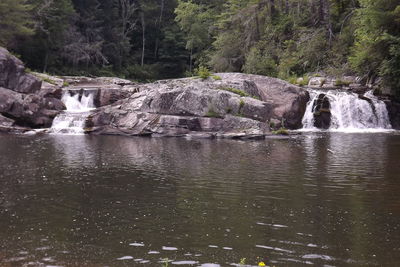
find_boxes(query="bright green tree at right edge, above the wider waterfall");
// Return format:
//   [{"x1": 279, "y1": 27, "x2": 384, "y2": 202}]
[{"x1": 350, "y1": 0, "x2": 400, "y2": 95}]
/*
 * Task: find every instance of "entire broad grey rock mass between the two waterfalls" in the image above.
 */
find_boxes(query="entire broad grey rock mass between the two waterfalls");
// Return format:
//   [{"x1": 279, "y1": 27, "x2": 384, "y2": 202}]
[{"x1": 88, "y1": 73, "x2": 309, "y2": 138}]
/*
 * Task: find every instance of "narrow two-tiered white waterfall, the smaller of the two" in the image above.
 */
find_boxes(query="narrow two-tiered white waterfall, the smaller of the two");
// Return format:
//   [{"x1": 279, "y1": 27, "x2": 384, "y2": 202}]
[{"x1": 50, "y1": 90, "x2": 95, "y2": 134}]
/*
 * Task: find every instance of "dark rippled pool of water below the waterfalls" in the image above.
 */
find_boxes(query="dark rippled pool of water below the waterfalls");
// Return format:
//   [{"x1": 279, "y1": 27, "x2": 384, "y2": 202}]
[{"x1": 0, "y1": 133, "x2": 400, "y2": 267}]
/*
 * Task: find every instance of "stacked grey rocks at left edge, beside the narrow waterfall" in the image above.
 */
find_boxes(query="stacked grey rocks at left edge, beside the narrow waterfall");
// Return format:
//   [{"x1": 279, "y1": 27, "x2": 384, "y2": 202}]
[{"x1": 0, "y1": 47, "x2": 65, "y2": 131}]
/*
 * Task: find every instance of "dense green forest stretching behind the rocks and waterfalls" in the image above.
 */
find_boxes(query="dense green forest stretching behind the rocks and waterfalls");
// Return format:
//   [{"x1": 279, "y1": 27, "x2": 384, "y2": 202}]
[{"x1": 0, "y1": 0, "x2": 400, "y2": 97}]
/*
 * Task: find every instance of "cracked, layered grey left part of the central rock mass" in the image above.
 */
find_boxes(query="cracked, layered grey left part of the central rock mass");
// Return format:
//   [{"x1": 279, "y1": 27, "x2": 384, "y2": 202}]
[{"x1": 87, "y1": 78, "x2": 273, "y2": 138}]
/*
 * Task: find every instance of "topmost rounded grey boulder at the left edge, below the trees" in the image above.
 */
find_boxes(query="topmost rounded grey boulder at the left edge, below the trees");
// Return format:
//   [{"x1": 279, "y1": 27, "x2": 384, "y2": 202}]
[{"x1": 0, "y1": 47, "x2": 42, "y2": 93}]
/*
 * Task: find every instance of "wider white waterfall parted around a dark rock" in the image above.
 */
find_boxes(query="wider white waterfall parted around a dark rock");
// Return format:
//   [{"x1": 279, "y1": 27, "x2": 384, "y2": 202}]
[{"x1": 302, "y1": 90, "x2": 392, "y2": 132}]
